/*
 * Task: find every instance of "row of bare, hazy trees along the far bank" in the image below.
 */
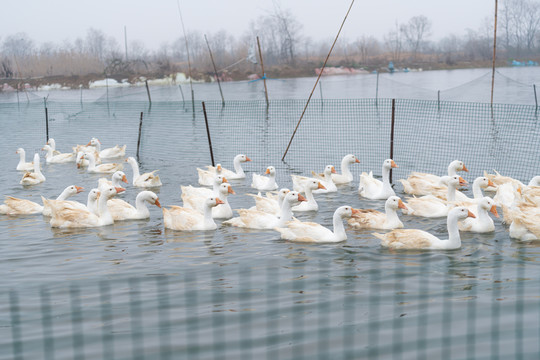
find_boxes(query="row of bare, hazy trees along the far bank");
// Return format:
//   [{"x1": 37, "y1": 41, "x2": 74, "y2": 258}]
[{"x1": 0, "y1": 0, "x2": 540, "y2": 78}]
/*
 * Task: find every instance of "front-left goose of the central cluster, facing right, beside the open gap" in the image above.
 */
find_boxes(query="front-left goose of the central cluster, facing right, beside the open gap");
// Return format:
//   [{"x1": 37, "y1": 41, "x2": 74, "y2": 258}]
[{"x1": 163, "y1": 197, "x2": 223, "y2": 231}]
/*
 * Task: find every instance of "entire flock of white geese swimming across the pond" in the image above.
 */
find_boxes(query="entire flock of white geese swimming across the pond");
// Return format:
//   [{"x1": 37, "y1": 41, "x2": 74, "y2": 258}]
[{"x1": 0, "y1": 142, "x2": 540, "y2": 250}]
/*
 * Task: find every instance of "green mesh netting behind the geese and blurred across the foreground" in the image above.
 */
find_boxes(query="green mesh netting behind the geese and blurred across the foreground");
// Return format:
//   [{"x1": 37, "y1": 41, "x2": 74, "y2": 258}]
[{"x1": 0, "y1": 98, "x2": 540, "y2": 359}]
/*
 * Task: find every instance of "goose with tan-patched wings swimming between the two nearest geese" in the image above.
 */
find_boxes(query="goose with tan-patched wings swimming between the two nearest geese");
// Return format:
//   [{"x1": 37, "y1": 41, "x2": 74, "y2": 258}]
[{"x1": 348, "y1": 196, "x2": 407, "y2": 230}]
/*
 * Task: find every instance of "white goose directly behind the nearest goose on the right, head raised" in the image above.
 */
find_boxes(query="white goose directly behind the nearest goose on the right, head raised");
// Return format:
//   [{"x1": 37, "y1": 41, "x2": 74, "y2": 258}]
[{"x1": 403, "y1": 175, "x2": 467, "y2": 218}]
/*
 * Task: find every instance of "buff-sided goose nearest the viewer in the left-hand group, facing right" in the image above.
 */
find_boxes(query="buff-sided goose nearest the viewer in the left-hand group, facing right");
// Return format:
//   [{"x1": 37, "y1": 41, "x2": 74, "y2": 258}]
[{"x1": 50, "y1": 186, "x2": 124, "y2": 228}]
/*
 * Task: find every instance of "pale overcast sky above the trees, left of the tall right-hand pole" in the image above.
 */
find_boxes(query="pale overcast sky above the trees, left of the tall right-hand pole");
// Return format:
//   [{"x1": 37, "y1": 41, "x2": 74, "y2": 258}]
[{"x1": 0, "y1": 0, "x2": 500, "y2": 50}]
